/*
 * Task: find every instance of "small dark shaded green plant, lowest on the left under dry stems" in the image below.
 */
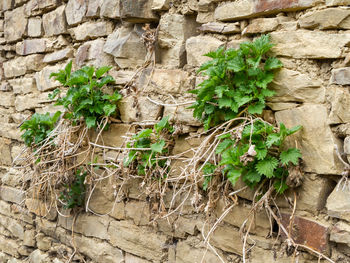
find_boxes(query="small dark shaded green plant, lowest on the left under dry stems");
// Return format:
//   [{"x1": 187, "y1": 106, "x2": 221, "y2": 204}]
[{"x1": 59, "y1": 169, "x2": 87, "y2": 209}]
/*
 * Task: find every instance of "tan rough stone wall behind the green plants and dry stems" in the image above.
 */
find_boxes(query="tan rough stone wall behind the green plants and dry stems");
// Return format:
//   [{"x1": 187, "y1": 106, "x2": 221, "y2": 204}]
[{"x1": 0, "y1": 0, "x2": 350, "y2": 263}]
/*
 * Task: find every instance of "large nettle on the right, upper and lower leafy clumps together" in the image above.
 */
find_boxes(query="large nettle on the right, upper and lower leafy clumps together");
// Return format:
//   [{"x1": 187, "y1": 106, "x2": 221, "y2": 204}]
[{"x1": 191, "y1": 35, "x2": 301, "y2": 193}]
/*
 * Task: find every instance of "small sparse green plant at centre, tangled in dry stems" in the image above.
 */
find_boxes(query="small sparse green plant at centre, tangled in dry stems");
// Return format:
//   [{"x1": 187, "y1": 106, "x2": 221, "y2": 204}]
[{"x1": 124, "y1": 117, "x2": 174, "y2": 175}]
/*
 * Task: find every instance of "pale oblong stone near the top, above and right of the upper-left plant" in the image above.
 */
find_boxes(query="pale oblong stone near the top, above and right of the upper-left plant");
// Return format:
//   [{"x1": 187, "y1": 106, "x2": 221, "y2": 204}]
[{"x1": 68, "y1": 21, "x2": 113, "y2": 41}]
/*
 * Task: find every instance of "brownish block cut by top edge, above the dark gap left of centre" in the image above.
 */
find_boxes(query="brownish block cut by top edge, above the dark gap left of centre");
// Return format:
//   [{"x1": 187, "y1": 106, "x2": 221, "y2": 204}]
[{"x1": 120, "y1": 0, "x2": 158, "y2": 23}]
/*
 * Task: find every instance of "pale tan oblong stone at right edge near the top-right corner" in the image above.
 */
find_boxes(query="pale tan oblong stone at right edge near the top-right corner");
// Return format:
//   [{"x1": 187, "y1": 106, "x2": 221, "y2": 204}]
[{"x1": 299, "y1": 8, "x2": 350, "y2": 29}]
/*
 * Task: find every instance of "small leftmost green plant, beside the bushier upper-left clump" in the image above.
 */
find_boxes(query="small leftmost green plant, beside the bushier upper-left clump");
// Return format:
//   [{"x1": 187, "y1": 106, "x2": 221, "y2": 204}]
[{"x1": 21, "y1": 111, "x2": 61, "y2": 147}]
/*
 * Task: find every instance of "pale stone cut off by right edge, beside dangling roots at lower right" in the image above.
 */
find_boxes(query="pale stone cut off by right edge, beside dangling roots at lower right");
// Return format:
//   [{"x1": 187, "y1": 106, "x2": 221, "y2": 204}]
[{"x1": 326, "y1": 184, "x2": 350, "y2": 222}]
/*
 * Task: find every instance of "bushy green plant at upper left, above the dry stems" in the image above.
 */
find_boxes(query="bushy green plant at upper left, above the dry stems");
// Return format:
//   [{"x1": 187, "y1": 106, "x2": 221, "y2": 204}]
[{"x1": 49, "y1": 61, "x2": 122, "y2": 128}]
